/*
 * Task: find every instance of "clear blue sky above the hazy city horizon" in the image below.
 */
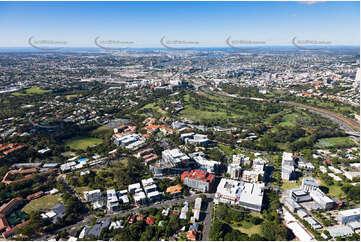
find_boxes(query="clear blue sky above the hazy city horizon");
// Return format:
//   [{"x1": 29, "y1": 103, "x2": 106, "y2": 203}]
[{"x1": 0, "y1": 2, "x2": 360, "y2": 47}]
